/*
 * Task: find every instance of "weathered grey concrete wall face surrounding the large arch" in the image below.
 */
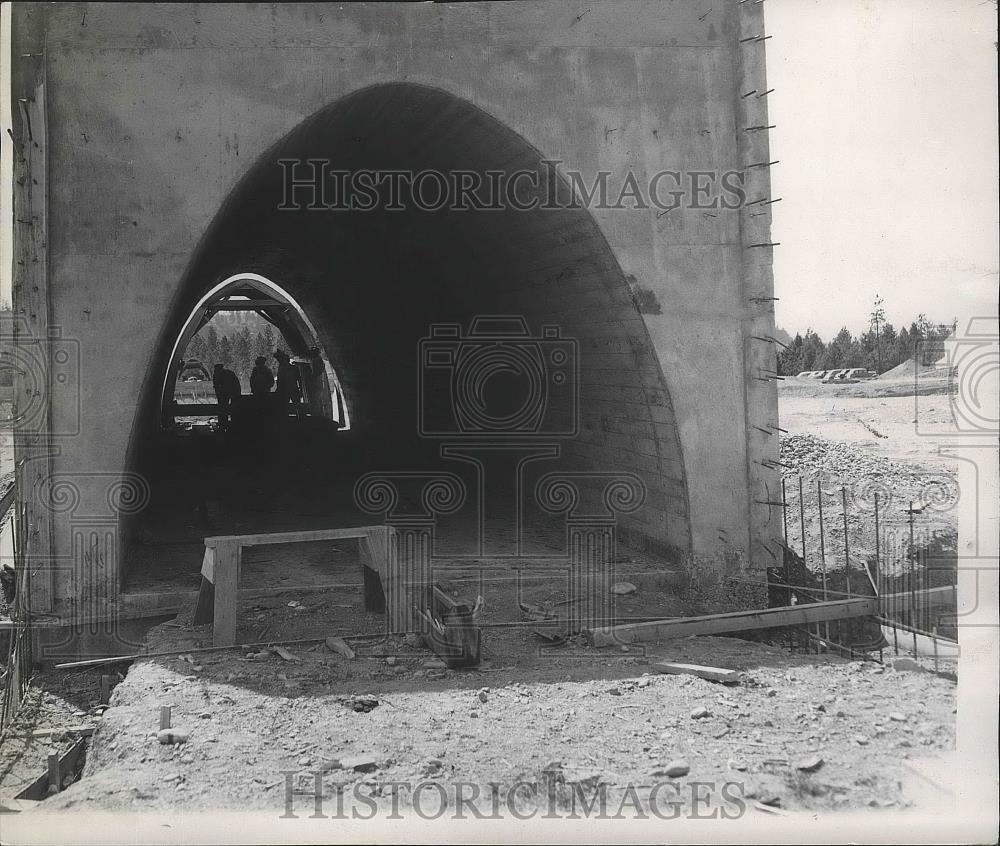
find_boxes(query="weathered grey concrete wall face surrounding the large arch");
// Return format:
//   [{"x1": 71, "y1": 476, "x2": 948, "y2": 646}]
[{"x1": 13, "y1": 0, "x2": 780, "y2": 624}]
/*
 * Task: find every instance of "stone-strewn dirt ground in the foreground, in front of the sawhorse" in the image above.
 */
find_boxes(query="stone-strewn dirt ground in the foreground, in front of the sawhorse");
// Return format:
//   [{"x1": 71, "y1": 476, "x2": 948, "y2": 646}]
[{"x1": 33, "y1": 629, "x2": 955, "y2": 814}]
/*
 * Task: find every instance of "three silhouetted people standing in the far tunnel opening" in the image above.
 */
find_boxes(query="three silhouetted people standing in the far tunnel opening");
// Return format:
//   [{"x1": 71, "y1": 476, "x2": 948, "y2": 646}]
[{"x1": 212, "y1": 350, "x2": 302, "y2": 432}]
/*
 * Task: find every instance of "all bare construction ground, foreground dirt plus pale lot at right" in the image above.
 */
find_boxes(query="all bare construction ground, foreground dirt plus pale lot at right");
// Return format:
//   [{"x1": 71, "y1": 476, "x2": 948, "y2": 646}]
[{"x1": 0, "y1": 386, "x2": 957, "y2": 816}]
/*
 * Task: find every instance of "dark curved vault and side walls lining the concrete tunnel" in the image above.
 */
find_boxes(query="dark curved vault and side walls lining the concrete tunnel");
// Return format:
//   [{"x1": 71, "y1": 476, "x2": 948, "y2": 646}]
[{"x1": 123, "y1": 83, "x2": 691, "y2": 588}]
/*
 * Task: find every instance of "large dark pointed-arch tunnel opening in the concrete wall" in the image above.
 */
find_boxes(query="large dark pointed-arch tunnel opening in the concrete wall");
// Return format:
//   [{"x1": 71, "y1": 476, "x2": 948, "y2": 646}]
[{"x1": 122, "y1": 83, "x2": 690, "y2": 628}]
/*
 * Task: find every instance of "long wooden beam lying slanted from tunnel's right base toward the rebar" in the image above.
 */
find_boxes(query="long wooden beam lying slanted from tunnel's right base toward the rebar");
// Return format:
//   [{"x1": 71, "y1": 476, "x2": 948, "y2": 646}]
[{"x1": 584, "y1": 597, "x2": 878, "y2": 646}]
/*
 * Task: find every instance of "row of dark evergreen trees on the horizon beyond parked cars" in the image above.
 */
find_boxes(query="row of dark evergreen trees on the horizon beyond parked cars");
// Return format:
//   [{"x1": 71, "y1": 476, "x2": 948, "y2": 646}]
[{"x1": 778, "y1": 308, "x2": 955, "y2": 376}]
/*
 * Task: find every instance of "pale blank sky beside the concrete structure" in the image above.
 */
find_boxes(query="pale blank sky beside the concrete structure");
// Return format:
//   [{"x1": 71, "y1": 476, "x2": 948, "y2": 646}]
[{"x1": 0, "y1": 0, "x2": 1000, "y2": 338}]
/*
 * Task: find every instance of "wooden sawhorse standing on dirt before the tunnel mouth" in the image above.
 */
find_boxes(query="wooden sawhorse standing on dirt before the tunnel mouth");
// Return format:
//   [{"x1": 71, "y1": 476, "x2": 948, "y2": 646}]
[{"x1": 194, "y1": 525, "x2": 396, "y2": 646}]
